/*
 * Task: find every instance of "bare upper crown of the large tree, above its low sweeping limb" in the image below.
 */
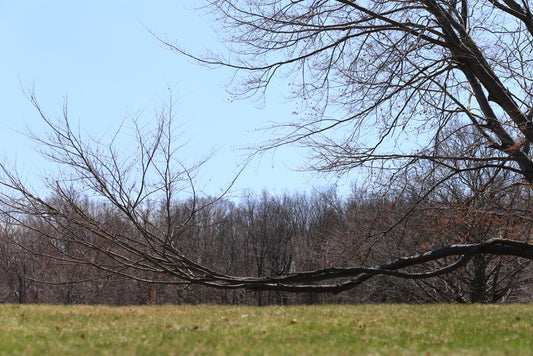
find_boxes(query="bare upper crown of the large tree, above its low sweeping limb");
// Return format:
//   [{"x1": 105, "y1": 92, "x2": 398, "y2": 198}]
[{"x1": 159, "y1": 0, "x2": 533, "y2": 292}]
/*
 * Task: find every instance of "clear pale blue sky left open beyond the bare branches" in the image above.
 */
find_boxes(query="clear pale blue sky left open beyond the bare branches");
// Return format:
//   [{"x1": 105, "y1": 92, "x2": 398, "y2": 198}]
[{"x1": 0, "y1": 0, "x2": 348, "y2": 194}]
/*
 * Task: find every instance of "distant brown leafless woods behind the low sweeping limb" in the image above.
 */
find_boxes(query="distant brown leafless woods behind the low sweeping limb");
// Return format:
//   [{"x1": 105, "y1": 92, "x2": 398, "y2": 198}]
[{"x1": 0, "y1": 187, "x2": 533, "y2": 305}]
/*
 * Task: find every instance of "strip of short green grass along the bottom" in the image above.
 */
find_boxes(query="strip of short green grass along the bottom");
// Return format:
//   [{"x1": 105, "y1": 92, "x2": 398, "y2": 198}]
[{"x1": 0, "y1": 305, "x2": 533, "y2": 356}]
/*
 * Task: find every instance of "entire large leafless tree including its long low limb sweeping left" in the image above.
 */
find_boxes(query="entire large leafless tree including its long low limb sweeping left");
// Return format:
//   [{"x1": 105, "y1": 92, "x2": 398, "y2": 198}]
[{"x1": 0, "y1": 0, "x2": 533, "y2": 293}]
